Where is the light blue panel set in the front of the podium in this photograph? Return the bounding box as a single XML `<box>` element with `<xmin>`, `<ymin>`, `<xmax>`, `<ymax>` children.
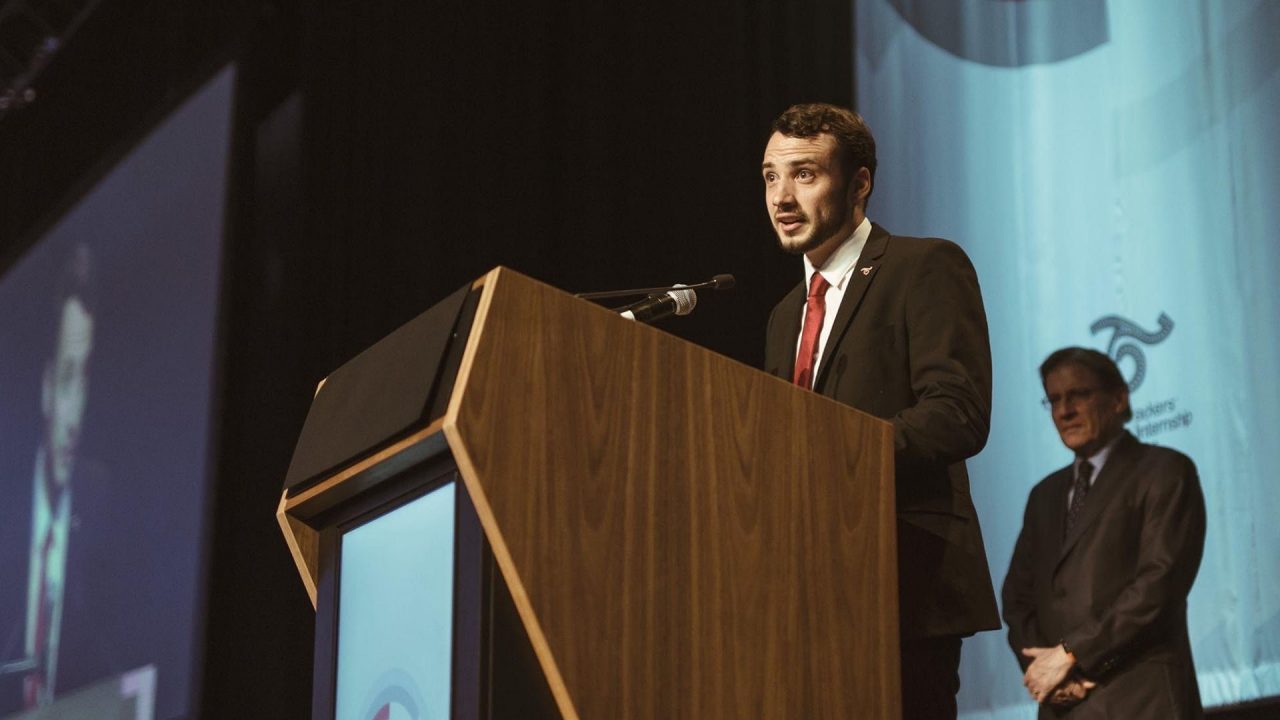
<box><xmin>334</xmin><ymin>482</ymin><xmax>456</xmax><ymax>720</ymax></box>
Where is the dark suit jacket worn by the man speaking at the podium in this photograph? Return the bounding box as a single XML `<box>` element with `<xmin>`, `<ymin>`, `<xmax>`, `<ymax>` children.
<box><xmin>764</xmin><ymin>224</ymin><xmax>1000</xmax><ymax>637</ymax></box>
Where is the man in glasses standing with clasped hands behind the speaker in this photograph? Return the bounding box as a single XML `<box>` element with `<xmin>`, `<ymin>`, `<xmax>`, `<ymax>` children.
<box><xmin>1004</xmin><ymin>347</ymin><xmax>1204</xmax><ymax>720</ymax></box>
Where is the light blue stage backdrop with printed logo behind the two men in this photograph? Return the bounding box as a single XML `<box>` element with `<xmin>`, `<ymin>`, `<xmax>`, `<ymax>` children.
<box><xmin>855</xmin><ymin>0</ymin><xmax>1280</xmax><ymax>719</ymax></box>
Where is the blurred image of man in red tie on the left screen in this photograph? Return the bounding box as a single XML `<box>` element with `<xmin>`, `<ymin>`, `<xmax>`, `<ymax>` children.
<box><xmin>23</xmin><ymin>245</ymin><xmax>93</xmax><ymax>708</ymax></box>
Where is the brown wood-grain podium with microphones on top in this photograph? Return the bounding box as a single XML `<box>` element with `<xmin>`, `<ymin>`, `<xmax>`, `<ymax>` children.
<box><xmin>278</xmin><ymin>268</ymin><xmax>901</xmax><ymax>720</ymax></box>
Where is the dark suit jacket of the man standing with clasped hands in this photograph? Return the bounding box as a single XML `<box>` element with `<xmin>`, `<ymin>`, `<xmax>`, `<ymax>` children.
<box><xmin>1002</xmin><ymin>433</ymin><xmax>1204</xmax><ymax>720</ymax></box>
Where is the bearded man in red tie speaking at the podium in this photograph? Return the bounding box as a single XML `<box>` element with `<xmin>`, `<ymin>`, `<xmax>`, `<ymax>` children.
<box><xmin>762</xmin><ymin>105</ymin><xmax>1000</xmax><ymax>719</ymax></box>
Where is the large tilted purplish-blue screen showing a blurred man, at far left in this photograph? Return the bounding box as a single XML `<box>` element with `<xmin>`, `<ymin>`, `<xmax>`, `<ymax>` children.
<box><xmin>0</xmin><ymin>68</ymin><xmax>234</xmax><ymax>720</ymax></box>
